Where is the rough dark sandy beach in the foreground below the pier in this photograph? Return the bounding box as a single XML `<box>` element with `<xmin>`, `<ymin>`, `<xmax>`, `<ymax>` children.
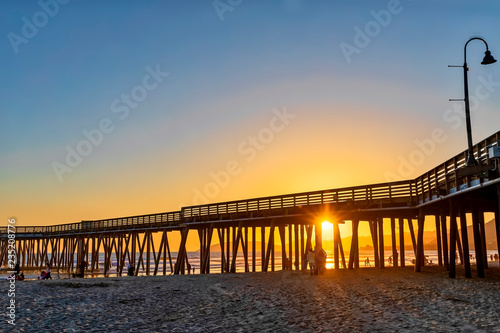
<box><xmin>0</xmin><ymin>267</ymin><xmax>500</xmax><ymax>332</ymax></box>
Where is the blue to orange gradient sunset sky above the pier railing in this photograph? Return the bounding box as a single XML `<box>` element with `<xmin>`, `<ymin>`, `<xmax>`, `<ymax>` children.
<box><xmin>0</xmin><ymin>0</ymin><xmax>500</xmax><ymax>239</ymax></box>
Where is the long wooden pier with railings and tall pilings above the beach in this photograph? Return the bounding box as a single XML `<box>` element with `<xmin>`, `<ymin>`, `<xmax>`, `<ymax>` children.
<box><xmin>0</xmin><ymin>132</ymin><xmax>500</xmax><ymax>277</ymax></box>
